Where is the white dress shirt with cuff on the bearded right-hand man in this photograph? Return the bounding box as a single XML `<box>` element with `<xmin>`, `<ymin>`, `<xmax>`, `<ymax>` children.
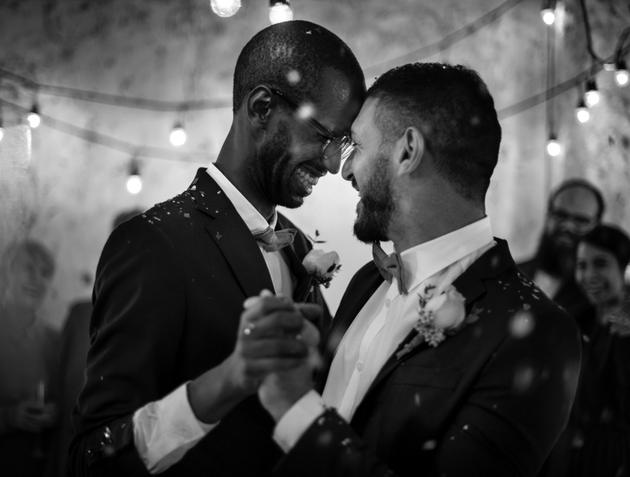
<box><xmin>274</xmin><ymin>217</ymin><xmax>495</xmax><ymax>452</ymax></box>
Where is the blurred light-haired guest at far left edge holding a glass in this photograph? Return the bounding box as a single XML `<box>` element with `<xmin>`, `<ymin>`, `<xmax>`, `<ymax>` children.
<box><xmin>0</xmin><ymin>240</ymin><xmax>57</xmax><ymax>477</ymax></box>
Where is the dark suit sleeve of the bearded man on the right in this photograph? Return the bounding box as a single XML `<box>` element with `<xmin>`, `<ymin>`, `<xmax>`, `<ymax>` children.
<box><xmin>275</xmin><ymin>304</ymin><xmax>580</xmax><ymax>477</ymax></box>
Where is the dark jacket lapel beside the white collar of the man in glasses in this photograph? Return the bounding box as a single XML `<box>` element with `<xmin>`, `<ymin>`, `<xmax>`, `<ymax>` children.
<box><xmin>186</xmin><ymin>169</ymin><xmax>273</xmax><ymax>296</ymax></box>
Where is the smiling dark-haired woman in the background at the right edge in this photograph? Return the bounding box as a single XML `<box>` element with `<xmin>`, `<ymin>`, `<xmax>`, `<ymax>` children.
<box><xmin>545</xmin><ymin>225</ymin><xmax>630</xmax><ymax>477</ymax></box>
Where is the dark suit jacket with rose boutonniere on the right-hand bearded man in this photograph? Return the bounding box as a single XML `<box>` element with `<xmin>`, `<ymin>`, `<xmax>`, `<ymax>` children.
<box><xmin>276</xmin><ymin>240</ymin><xmax>580</xmax><ymax>477</ymax></box>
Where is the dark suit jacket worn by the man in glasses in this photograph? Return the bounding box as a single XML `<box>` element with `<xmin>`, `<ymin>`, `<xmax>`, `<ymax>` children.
<box><xmin>70</xmin><ymin>169</ymin><xmax>327</xmax><ymax>477</ymax></box>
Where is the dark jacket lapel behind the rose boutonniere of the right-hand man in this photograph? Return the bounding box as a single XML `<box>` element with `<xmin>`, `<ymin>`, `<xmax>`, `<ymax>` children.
<box><xmin>352</xmin><ymin>239</ymin><xmax>514</xmax><ymax>422</ymax></box>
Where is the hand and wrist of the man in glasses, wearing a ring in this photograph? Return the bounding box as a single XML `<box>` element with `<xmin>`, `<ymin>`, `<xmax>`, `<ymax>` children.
<box><xmin>187</xmin><ymin>291</ymin><xmax>316</xmax><ymax>423</ymax></box>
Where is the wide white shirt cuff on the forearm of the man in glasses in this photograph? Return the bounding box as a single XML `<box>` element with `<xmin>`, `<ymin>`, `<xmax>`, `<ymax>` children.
<box><xmin>133</xmin><ymin>383</ymin><xmax>218</xmax><ymax>474</ymax></box>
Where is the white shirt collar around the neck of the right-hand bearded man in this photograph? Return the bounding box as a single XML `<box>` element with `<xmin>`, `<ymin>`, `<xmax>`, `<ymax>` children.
<box><xmin>400</xmin><ymin>217</ymin><xmax>494</xmax><ymax>291</ymax></box>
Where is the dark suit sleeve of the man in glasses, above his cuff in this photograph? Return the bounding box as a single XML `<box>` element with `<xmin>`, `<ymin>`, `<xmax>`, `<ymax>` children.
<box><xmin>69</xmin><ymin>217</ymin><xmax>186</xmax><ymax>476</ymax></box>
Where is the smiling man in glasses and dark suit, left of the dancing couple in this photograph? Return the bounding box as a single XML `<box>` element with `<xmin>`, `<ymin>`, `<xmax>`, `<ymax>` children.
<box><xmin>70</xmin><ymin>21</ymin><xmax>365</xmax><ymax>477</ymax></box>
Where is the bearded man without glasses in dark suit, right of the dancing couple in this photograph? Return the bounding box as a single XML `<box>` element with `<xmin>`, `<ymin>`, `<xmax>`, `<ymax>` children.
<box><xmin>248</xmin><ymin>63</ymin><xmax>580</xmax><ymax>477</ymax></box>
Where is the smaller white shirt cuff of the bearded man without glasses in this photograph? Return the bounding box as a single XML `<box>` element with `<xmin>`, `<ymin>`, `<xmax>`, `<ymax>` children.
<box><xmin>273</xmin><ymin>390</ymin><xmax>326</xmax><ymax>452</ymax></box>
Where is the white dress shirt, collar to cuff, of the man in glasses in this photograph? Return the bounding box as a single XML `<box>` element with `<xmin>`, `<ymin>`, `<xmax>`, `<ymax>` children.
<box><xmin>133</xmin><ymin>164</ymin><xmax>293</xmax><ymax>474</ymax></box>
